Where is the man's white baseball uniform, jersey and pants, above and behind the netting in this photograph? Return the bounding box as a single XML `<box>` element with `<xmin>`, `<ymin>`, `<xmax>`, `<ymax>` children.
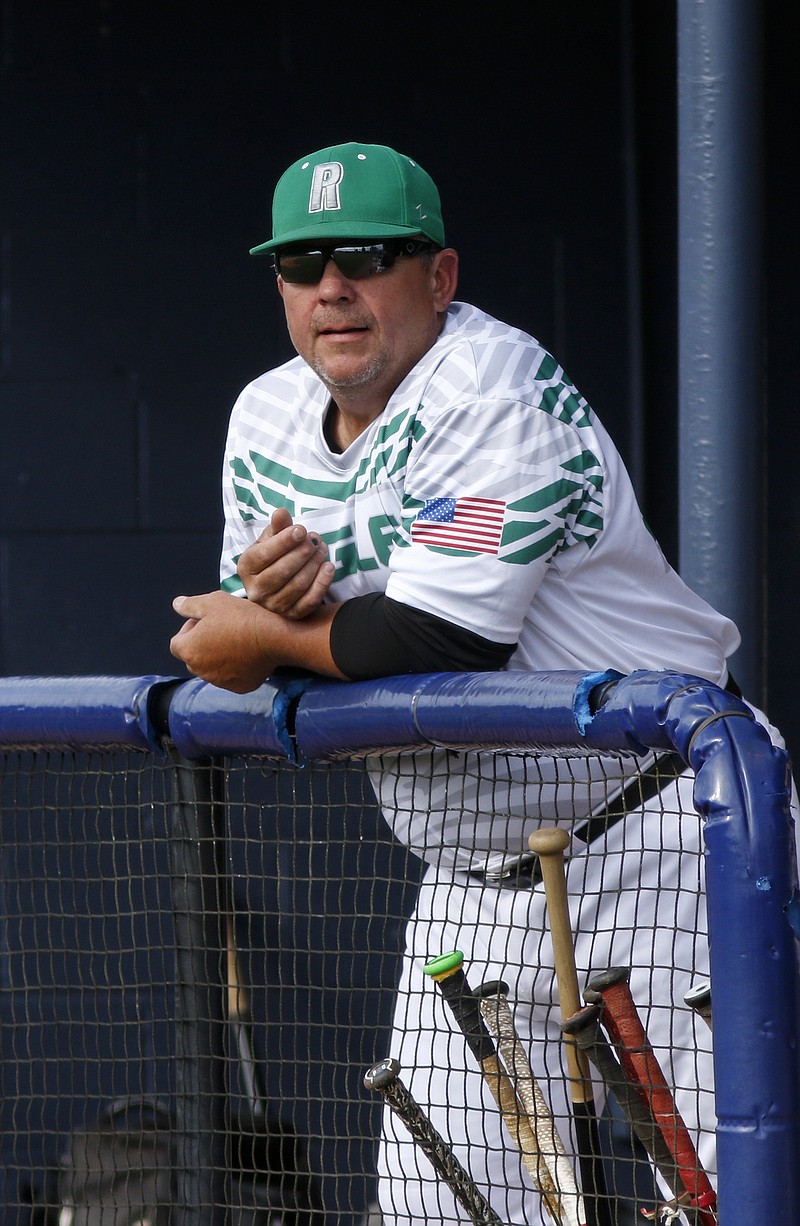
<box><xmin>222</xmin><ymin>303</ymin><xmax>759</xmax><ymax>1226</ymax></box>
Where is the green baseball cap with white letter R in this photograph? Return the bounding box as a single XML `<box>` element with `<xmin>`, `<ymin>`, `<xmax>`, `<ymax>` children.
<box><xmin>250</xmin><ymin>141</ymin><xmax>445</xmax><ymax>255</ymax></box>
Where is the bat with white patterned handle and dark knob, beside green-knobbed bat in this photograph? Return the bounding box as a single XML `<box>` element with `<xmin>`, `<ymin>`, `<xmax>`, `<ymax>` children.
<box><xmin>473</xmin><ymin>980</ymin><xmax>586</xmax><ymax>1226</ymax></box>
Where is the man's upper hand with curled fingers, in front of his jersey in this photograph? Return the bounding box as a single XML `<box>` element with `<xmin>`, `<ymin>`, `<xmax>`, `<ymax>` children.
<box><xmin>238</xmin><ymin>508</ymin><xmax>336</xmax><ymax>620</ymax></box>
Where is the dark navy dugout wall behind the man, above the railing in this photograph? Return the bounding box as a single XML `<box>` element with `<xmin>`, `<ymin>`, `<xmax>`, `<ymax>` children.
<box><xmin>0</xmin><ymin>0</ymin><xmax>800</xmax><ymax>745</ymax></box>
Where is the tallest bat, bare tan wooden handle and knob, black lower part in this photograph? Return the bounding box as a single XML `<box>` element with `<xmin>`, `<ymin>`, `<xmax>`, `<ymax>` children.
<box><xmin>528</xmin><ymin>826</ymin><xmax>614</xmax><ymax>1226</ymax></box>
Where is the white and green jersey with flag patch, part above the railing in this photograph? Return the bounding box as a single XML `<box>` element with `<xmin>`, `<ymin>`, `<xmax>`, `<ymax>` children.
<box><xmin>221</xmin><ymin>296</ymin><xmax>739</xmax><ymax>682</ymax></box>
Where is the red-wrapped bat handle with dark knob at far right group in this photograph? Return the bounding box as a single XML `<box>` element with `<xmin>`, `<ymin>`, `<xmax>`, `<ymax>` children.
<box><xmin>589</xmin><ymin>967</ymin><xmax>718</xmax><ymax>1226</ymax></box>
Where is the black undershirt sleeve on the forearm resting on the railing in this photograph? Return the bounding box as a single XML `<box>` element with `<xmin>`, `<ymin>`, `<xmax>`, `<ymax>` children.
<box><xmin>331</xmin><ymin>592</ymin><xmax>516</xmax><ymax>680</ymax></box>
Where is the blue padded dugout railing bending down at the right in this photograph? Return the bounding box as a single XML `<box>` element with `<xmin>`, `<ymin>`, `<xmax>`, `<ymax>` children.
<box><xmin>0</xmin><ymin>672</ymin><xmax>800</xmax><ymax>1226</ymax></box>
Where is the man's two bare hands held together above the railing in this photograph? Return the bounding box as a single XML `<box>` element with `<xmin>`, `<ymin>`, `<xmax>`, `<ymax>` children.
<box><xmin>169</xmin><ymin>509</ymin><xmax>334</xmax><ymax>694</ymax></box>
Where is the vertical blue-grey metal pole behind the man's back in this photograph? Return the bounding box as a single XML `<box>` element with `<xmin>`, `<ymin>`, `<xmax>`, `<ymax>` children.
<box><xmin>677</xmin><ymin>0</ymin><xmax>764</xmax><ymax>702</ymax></box>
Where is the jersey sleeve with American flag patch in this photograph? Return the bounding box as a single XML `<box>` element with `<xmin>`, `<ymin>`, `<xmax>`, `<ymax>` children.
<box><xmin>386</xmin><ymin>384</ymin><xmax>604</xmax><ymax>642</ymax></box>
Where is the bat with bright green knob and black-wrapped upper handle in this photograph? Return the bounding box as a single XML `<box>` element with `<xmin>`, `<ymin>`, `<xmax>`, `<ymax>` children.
<box><xmin>424</xmin><ymin>950</ymin><xmax>566</xmax><ymax>1226</ymax></box>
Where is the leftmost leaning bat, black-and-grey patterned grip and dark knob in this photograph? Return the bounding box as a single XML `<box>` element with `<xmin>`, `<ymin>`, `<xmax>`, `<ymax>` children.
<box><xmin>364</xmin><ymin>1057</ymin><xmax>502</xmax><ymax>1226</ymax></box>
